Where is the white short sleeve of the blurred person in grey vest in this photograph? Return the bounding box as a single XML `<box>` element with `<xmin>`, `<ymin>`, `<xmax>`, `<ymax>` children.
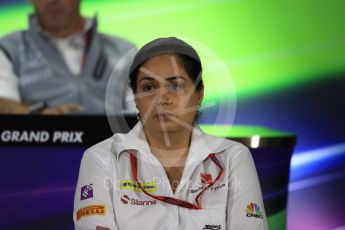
<box><xmin>0</xmin><ymin>49</ymin><xmax>21</xmax><ymax>102</ymax></box>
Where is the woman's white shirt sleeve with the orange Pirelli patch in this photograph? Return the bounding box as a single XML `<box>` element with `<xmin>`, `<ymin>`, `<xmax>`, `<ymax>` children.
<box><xmin>73</xmin><ymin>152</ymin><xmax>118</xmax><ymax>230</ymax></box>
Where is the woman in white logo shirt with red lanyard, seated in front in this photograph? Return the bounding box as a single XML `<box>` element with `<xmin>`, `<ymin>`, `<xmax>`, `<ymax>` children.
<box><xmin>73</xmin><ymin>38</ymin><xmax>267</xmax><ymax>230</ymax></box>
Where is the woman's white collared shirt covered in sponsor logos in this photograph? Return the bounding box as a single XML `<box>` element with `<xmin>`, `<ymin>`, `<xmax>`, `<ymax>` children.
<box><xmin>73</xmin><ymin>122</ymin><xmax>267</xmax><ymax>230</ymax></box>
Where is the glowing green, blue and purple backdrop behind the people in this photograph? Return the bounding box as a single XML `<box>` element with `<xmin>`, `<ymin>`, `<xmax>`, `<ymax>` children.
<box><xmin>0</xmin><ymin>0</ymin><xmax>345</xmax><ymax>229</ymax></box>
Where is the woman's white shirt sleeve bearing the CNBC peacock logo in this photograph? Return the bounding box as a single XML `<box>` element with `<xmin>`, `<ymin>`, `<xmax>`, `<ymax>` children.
<box><xmin>226</xmin><ymin>148</ymin><xmax>268</xmax><ymax>230</ymax></box>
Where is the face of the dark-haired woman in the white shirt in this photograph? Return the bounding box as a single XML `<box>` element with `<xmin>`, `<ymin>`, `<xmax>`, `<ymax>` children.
<box><xmin>135</xmin><ymin>54</ymin><xmax>203</xmax><ymax>132</ymax></box>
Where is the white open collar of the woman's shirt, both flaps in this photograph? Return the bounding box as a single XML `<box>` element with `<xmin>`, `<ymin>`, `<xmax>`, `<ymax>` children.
<box><xmin>112</xmin><ymin>122</ymin><xmax>234</xmax><ymax>165</ymax></box>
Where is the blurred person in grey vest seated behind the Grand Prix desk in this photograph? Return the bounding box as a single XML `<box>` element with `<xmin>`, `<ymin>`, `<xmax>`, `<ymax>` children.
<box><xmin>0</xmin><ymin>0</ymin><xmax>134</xmax><ymax>114</ymax></box>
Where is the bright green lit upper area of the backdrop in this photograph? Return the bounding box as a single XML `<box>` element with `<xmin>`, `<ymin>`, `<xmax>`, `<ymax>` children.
<box><xmin>0</xmin><ymin>0</ymin><xmax>345</xmax><ymax>101</ymax></box>
